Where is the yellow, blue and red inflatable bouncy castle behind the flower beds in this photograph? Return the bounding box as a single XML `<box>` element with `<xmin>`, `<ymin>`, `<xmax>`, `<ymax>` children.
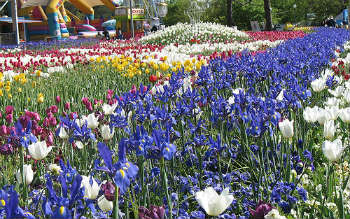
<box><xmin>19</xmin><ymin>0</ymin><xmax>120</xmax><ymax>40</ymax></box>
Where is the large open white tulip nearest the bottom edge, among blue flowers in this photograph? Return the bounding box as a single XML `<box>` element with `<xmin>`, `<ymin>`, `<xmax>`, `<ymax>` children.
<box><xmin>195</xmin><ymin>187</ymin><xmax>233</xmax><ymax>216</ymax></box>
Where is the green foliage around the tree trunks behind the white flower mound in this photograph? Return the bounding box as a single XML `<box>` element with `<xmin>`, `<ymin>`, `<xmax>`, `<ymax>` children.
<box><xmin>164</xmin><ymin>0</ymin><xmax>346</xmax><ymax>30</ymax></box>
